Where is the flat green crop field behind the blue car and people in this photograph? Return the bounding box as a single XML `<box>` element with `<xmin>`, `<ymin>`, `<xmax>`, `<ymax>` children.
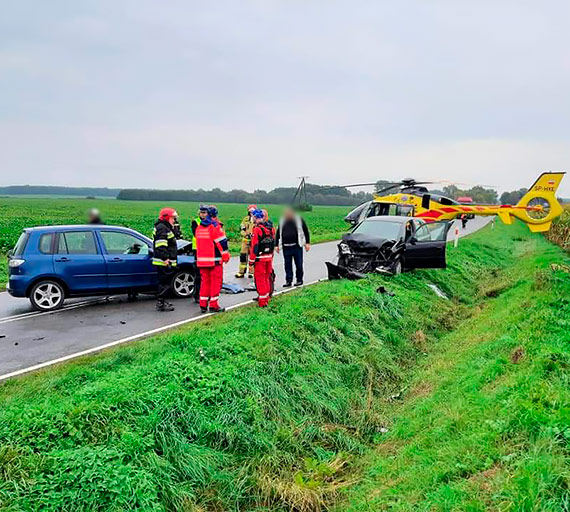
<box><xmin>0</xmin><ymin>197</ymin><xmax>352</xmax><ymax>286</ymax></box>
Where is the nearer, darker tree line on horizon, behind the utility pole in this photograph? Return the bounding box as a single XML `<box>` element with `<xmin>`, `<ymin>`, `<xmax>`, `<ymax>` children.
<box><xmin>117</xmin><ymin>184</ymin><xmax>372</xmax><ymax>206</ymax></box>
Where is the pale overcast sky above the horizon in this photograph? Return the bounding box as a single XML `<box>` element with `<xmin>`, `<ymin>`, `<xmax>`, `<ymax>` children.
<box><xmin>0</xmin><ymin>0</ymin><xmax>570</xmax><ymax>196</ymax></box>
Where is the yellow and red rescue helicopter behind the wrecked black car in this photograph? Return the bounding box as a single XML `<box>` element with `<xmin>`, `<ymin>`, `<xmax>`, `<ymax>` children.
<box><xmin>338</xmin><ymin>172</ymin><xmax>565</xmax><ymax>233</ymax></box>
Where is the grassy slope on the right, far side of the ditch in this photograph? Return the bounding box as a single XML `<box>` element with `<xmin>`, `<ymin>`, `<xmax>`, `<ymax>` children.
<box><xmin>339</xmin><ymin>227</ymin><xmax>570</xmax><ymax>512</ymax></box>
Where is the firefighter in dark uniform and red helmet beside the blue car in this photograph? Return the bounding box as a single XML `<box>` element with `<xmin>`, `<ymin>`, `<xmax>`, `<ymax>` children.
<box><xmin>152</xmin><ymin>208</ymin><xmax>178</xmax><ymax>311</ymax></box>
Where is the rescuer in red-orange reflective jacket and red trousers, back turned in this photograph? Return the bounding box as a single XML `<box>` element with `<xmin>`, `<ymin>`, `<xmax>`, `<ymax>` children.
<box><xmin>196</xmin><ymin>206</ymin><xmax>230</xmax><ymax>313</ymax></box>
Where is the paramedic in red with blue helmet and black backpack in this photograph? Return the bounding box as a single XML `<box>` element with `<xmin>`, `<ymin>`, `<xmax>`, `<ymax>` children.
<box><xmin>249</xmin><ymin>210</ymin><xmax>275</xmax><ymax>308</ymax></box>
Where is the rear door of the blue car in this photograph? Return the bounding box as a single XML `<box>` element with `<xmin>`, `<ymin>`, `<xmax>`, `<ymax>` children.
<box><xmin>53</xmin><ymin>229</ymin><xmax>107</xmax><ymax>293</ymax></box>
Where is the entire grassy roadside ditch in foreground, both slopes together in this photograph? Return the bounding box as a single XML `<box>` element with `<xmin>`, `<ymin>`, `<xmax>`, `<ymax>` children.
<box><xmin>0</xmin><ymin>225</ymin><xmax>570</xmax><ymax>511</ymax></box>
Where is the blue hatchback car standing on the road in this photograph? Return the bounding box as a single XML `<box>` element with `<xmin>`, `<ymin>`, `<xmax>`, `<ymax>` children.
<box><xmin>8</xmin><ymin>225</ymin><xmax>195</xmax><ymax>311</ymax></box>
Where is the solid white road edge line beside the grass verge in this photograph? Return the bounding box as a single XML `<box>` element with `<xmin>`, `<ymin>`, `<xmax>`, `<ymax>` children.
<box><xmin>0</xmin><ymin>279</ymin><xmax>323</xmax><ymax>381</ymax></box>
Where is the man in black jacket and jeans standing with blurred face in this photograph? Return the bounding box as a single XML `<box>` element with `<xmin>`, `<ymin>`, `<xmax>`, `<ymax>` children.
<box><xmin>275</xmin><ymin>208</ymin><xmax>311</xmax><ymax>288</ymax></box>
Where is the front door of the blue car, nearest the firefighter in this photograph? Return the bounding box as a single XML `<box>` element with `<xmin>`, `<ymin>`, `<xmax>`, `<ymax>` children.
<box><xmin>99</xmin><ymin>228</ymin><xmax>157</xmax><ymax>291</ymax></box>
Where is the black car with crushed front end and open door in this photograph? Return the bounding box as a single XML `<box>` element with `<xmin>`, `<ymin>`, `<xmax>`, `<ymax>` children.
<box><xmin>326</xmin><ymin>215</ymin><xmax>452</xmax><ymax>279</ymax></box>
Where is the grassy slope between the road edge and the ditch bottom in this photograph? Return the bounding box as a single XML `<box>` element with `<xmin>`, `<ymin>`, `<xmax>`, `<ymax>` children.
<box><xmin>0</xmin><ymin>225</ymin><xmax>566</xmax><ymax>511</ymax></box>
